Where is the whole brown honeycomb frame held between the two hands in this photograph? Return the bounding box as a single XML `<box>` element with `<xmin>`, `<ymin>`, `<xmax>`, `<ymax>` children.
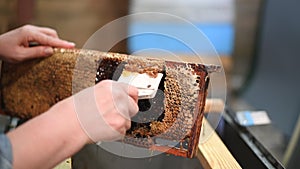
<box><xmin>1</xmin><ymin>49</ymin><xmax>214</xmax><ymax>158</ymax></box>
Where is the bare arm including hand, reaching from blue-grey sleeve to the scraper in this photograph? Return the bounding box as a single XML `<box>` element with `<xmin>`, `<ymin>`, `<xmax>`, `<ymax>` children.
<box><xmin>8</xmin><ymin>80</ymin><xmax>138</xmax><ymax>169</ymax></box>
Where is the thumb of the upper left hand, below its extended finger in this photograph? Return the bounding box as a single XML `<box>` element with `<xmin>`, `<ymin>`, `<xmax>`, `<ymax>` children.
<box><xmin>22</xmin><ymin>46</ymin><xmax>54</xmax><ymax>59</ymax></box>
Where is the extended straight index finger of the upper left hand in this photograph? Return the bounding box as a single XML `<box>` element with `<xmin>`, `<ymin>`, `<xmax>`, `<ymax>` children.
<box><xmin>30</xmin><ymin>32</ymin><xmax>75</xmax><ymax>48</ymax></box>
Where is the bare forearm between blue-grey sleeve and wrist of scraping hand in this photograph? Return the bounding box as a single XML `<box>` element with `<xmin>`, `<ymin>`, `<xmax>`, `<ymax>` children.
<box><xmin>8</xmin><ymin>98</ymin><xmax>88</xmax><ymax>169</ymax></box>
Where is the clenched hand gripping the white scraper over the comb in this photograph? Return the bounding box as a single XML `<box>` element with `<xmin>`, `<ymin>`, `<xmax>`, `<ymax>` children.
<box><xmin>74</xmin><ymin>80</ymin><xmax>138</xmax><ymax>142</ymax></box>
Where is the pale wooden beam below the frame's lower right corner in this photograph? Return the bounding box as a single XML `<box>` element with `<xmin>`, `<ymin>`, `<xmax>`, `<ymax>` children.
<box><xmin>197</xmin><ymin>118</ymin><xmax>241</xmax><ymax>169</ymax></box>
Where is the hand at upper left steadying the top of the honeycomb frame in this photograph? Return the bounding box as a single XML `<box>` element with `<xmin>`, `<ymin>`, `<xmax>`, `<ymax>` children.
<box><xmin>0</xmin><ymin>25</ymin><xmax>75</xmax><ymax>63</ymax></box>
